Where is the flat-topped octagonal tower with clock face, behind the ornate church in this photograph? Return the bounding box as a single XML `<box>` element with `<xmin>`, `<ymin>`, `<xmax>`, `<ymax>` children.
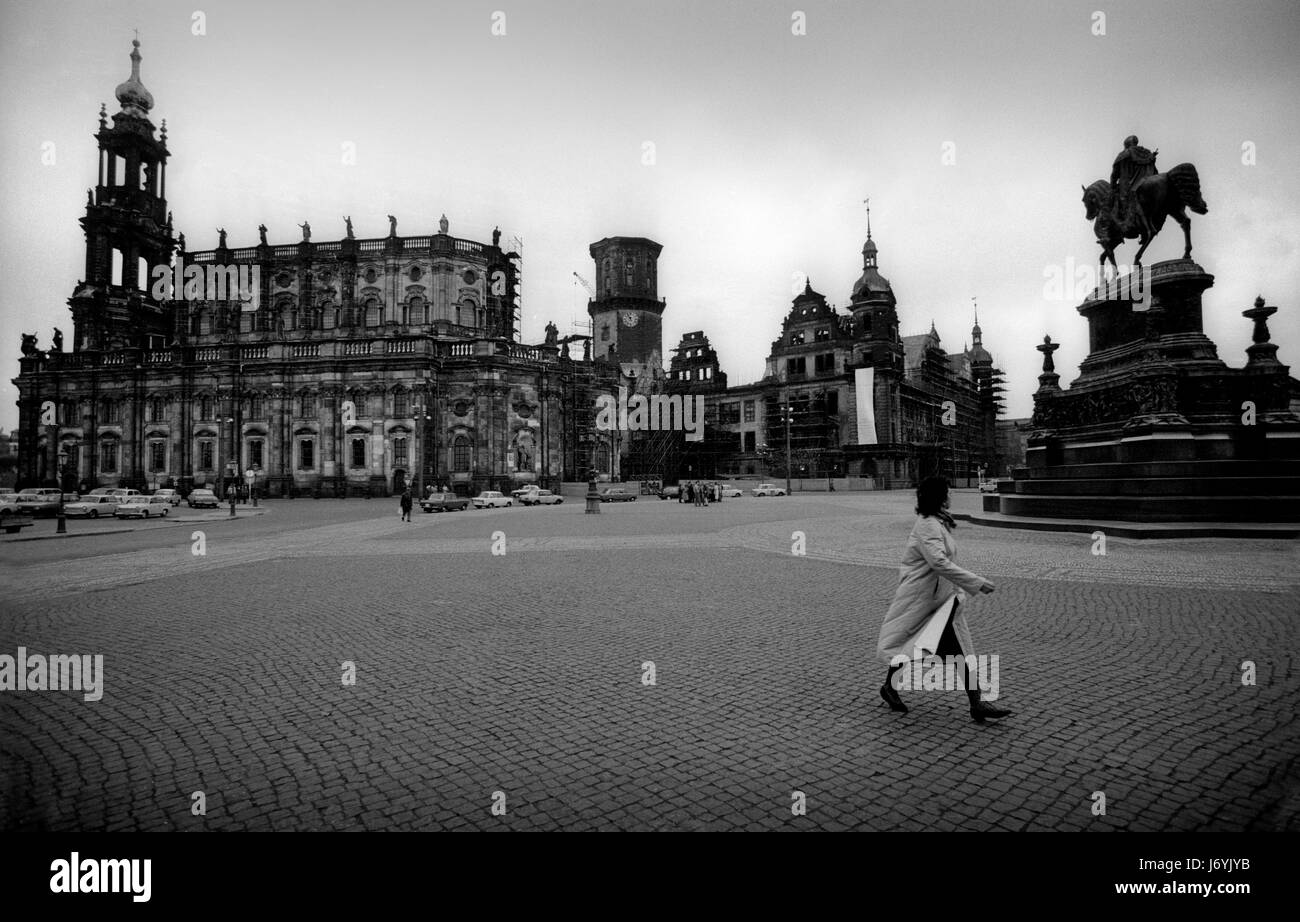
<box><xmin>586</xmin><ymin>237</ymin><xmax>667</xmax><ymax>376</ymax></box>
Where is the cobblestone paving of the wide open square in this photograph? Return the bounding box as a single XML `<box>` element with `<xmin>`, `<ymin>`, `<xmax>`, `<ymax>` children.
<box><xmin>0</xmin><ymin>494</ymin><xmax>1300</xmax><ymax>830</ymax></box>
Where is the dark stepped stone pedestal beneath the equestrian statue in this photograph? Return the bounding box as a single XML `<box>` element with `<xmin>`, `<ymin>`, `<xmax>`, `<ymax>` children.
<box><xmin>984</xmin><ymin>259</ymin><xmax>1300</xmax><ymax>521</ymax></box>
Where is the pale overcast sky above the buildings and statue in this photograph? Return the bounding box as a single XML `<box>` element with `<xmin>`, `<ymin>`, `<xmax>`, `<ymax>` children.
<box><xmin>0</xmin><ymin>0</ymin><xmax>1300</xmax><ymax>429</ymax></box>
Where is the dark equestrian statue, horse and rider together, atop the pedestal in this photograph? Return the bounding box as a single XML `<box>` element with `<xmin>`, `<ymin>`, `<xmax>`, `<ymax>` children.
<box><xmin>1083</xmin><ymin>135</ymin><xmax>1208</xmax><ymax>273</ymax></box>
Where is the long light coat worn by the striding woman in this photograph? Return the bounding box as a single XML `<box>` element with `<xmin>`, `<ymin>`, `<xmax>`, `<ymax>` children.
<box><xmin>876</xmin><ymin>515</ymin><xmax>984</xmax><ymax>663</ymax></box>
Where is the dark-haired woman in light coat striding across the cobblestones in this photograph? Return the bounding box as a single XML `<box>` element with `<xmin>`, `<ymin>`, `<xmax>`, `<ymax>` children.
<box><xmin>876</xmin><ymin>477</ymin><xmax>1011</xmax><ymax>723</ymax></box>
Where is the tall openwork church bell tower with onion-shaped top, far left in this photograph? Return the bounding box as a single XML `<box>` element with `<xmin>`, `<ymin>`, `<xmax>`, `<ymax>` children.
<box><xmin>68</xmin><ymin>40</ymin><xmax>176</xmax><ymax>351</ymax></box>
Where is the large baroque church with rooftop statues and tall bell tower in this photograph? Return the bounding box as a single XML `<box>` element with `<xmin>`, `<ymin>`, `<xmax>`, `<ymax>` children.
<box><xmin>14</xmin><ymin>42</ymin><xmax>626</xmax><ymax>495</ymax></box>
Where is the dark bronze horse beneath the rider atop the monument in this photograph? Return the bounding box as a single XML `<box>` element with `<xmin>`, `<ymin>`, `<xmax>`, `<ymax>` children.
<box><xmin>1083</xmin><ymin>164</ymin><xmax>1209</xmax><ymax>274</ymax></box>
